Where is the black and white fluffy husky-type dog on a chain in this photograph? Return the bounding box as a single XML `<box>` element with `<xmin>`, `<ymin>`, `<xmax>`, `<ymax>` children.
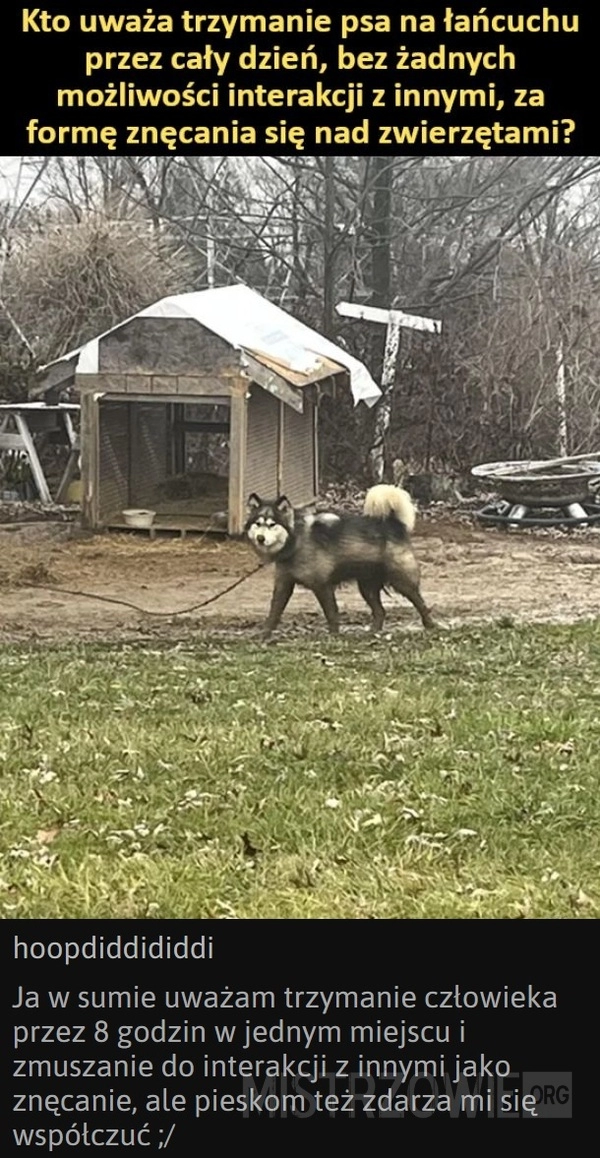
<box><xmin>244</xmin><ymin>485</ymin><xmax>434</xmax><ymax>639</ymax></box>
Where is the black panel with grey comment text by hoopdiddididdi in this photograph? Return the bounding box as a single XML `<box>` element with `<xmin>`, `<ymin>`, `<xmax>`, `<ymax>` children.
<box><xmin>2</xmin><ymin>921</ymin><xmax>597</xmax><ymax>1155</ymax></box>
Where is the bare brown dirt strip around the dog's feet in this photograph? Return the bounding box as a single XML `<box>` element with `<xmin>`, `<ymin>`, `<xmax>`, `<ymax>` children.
<box><xmin>0</xmin><ymin>515</ymin><xmax>600</xmax><ymax>642</ymax></box>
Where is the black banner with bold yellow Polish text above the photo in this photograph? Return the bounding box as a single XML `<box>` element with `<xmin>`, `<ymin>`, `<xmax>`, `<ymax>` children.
<box><xmin>1</xmin><ymin>2</ymin><xmax>599</xmax><ymax>155</ymax></box>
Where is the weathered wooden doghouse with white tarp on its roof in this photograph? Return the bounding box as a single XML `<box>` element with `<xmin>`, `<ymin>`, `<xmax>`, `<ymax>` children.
<box><xmin>35</xmin><ymin>285</ymin><xmax>380</xmax><ymax>535</ymax></box>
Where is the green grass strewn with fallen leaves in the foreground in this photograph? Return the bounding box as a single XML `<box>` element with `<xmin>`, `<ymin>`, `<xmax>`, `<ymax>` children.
<box><xmin>0</xmin><ymin>622</ymin><xmax>600</xmax><ymax>918</ymax></box>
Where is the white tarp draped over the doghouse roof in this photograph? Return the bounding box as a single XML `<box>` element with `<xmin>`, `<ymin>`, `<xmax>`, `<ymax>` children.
<box><xmin>51</xmin><ymin>285</ymin><xmax>381</xmax><ymax>406</ymax></box>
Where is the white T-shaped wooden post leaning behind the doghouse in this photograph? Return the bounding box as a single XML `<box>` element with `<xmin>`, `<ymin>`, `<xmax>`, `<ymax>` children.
<box><xmin>336</xmin><ymin>301</ymin><xmax>441</xmax><ymax>483</ymax></box>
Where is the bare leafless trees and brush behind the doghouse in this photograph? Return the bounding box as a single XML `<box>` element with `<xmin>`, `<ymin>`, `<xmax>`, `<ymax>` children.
<box><xmin>2</xmin><ymin>155</ymin><xmax>600</xmax><ymax>477</ymax></box>
